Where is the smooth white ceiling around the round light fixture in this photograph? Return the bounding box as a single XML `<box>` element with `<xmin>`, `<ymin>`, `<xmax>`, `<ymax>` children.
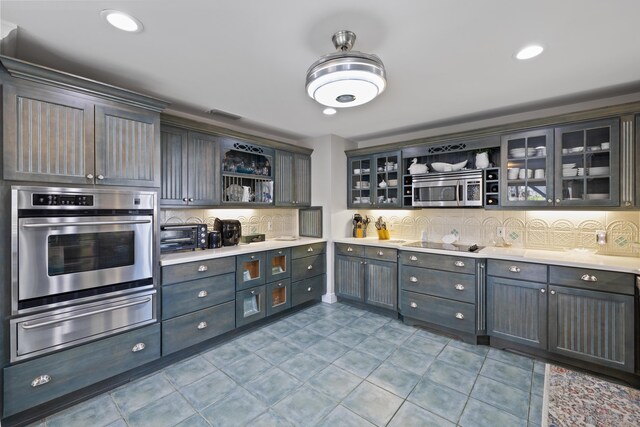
<box><xmin>0</xmin><ymin>0</ymin><xmax>640</xmax><ymax>141</ymax></box>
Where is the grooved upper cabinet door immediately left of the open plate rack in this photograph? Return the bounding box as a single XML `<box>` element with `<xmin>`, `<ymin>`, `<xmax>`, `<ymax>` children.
<box><xmin>187</xmin><ymin>132</ymin><xmax>221</xmax><ymax>206</ymax></box>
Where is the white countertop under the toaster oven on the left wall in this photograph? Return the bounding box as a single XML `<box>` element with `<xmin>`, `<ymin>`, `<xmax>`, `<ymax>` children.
<box><xmin>160</xmin><ymin>237</ymin><xmax>326</xmax><ymax>266</ymax></box>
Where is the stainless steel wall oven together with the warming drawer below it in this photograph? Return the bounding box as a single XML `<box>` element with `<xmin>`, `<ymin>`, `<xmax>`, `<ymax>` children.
<box><xmin>10</xmin><ymin>186</ymin><xmax>156</xmax><ymax>361</ymax></box>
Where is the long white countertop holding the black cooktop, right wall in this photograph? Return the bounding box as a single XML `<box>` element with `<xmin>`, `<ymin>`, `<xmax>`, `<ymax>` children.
<box><xmin>334</xmin><ymin>237</ymin><xmax>640</xmax><ymax>274</ymax></box>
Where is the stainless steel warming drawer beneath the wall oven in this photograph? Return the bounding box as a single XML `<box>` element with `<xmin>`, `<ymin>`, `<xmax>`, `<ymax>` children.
<box><xmin>11</xmin><ymin>290</ymin><xmax>156</xmax><ymax>362</ymax></box>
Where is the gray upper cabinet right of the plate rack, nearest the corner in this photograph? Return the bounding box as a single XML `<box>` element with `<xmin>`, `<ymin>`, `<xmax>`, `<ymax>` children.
<box><xmin>275</xmin><ymin>150</ymin><xmax>311</xmax><ymax>207</ymax></box>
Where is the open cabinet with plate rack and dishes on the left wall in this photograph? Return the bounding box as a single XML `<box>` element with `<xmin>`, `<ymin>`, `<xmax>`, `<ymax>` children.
<box><xmin>221</xmin><ymin>138</ymin><xmax>275</xmax><ymax>205</ymax></box>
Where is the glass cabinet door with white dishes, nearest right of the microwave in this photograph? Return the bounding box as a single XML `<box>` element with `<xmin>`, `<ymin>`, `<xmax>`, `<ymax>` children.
<box><xmin>500</xmin><ymin>129</ymin><xmax>554</xmax><ymax>206</ymax></box>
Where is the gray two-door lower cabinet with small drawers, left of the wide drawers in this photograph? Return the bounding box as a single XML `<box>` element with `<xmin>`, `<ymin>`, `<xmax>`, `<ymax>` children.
<box><xmin>334</xmin><ymin>243</ymin><xmax>398</xmax><ymax>310</ymax></box>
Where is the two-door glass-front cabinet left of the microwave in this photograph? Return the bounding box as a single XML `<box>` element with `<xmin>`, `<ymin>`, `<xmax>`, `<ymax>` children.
<box><xmin>347</xmin><ymin>151</ymin><xmax>402</xmax><ymax>208</ymax></box>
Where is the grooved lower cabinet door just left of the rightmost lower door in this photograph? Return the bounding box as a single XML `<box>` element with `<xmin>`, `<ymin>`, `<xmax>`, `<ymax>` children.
<box><xmin>487</xmin><ymin>277</ymin><xmax>547</xmax><ymax>349</ymax></box>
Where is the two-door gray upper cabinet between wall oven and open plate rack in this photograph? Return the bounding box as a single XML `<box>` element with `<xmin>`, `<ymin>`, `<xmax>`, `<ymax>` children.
<box><xmin>160</xmin><ymin>126</ymin><xmax>220</xmax><ymax>206</ymax></box>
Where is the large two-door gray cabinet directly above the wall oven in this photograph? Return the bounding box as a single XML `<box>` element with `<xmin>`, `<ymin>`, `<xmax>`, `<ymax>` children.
<box><xmin>3</xmin><ymin>83</ymin><xmax>160</xmax><ymax>187</ymax></box>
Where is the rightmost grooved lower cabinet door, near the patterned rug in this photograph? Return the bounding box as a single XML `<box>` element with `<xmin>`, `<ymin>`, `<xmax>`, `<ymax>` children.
<box><xmin>549</xmin><ymin>286</ymin><xmax>634</xmax><ymax>372</ymax></box>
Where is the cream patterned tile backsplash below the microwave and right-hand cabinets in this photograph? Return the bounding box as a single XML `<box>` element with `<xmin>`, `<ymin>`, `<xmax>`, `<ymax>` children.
<box><xmin>354</xmin><ymin>209</ymin><xmax>640</xmax><ymax>256</ymax></box>
